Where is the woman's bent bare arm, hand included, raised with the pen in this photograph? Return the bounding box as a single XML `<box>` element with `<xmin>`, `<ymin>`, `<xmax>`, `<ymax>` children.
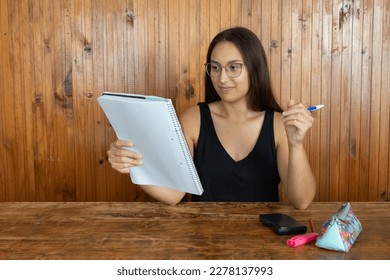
<box><xmin>274</xmin><ymin>101</ymin><xmax>316</xmax><ymax>209</ymax></box>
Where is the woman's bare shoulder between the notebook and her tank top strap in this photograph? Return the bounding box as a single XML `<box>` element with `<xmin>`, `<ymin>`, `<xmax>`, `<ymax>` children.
<box><xmin>179</xmin><ymin>105</ymin><xmax>200</xmax><ymax>145</ymax></box>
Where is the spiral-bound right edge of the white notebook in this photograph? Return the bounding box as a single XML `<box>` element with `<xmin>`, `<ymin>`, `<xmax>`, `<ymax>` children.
<box><xmin>167</xmin><ymin>99</ymin><xmax>203</xmax><ymax>194</ymax></box>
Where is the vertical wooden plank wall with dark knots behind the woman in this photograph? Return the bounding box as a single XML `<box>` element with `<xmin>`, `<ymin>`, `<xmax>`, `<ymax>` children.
<box><xmin>0</xmin><ymin>0</ymin><xmax>390</xmax><ymax>201</ymax></box>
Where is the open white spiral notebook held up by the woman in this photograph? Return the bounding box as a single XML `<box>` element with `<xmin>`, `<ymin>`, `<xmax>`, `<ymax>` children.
<box><xmin>98</xmin><ymin>92</ymin><xmax>203</xmax><ymax>195</ymax></box>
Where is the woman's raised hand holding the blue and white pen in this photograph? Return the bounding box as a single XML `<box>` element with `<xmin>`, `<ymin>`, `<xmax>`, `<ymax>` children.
<box><xmin>283</xmin><ymin>100</ymin><xmax>314</xmax><ymax>145</ymax></box>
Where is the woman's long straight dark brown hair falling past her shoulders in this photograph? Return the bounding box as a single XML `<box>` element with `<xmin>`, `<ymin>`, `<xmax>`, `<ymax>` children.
<box><xmin>205</xmin><ymin>27</ymin><xmax>283</xmax><ymax>112</ymax></box>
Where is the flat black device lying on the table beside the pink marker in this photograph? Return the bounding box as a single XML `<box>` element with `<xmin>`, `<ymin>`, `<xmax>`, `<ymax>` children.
<box><xmin>259</xmin><ymin>213</ymin><xmax>307</xmax><ymax>235</ymax></box>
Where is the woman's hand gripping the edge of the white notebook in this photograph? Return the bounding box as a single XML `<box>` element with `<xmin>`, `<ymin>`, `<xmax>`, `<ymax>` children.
<box><xmin>107</xmin><ymin>140</ymin><xmax>142</xmax><ymax>173</ymax></box>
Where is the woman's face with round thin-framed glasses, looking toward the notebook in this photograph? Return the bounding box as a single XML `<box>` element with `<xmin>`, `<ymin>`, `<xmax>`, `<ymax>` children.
<box><xmin>210</xmin><ymin>41</ymin><xmax>249</xmax><ymax>105</ymax></box>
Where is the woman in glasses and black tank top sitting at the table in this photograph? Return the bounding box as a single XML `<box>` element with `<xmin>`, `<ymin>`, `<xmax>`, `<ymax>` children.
<box><xmin>108</xmin><ymin>27</ymin><xmax>316</xmax><ymax>209</ymax></box>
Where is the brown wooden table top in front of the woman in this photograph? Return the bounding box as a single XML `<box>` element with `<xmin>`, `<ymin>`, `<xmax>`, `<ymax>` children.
<box><xmin>0</xmin><ymin>202</ymin><xmax>390</xmax><ymax>260</ymax></box>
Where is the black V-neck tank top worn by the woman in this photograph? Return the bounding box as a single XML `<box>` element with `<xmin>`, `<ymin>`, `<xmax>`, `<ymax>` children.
<box><xmin>192</xmin><ymin>103</ymin><xmax>280</xmax><ymax>202</ymax></box>
